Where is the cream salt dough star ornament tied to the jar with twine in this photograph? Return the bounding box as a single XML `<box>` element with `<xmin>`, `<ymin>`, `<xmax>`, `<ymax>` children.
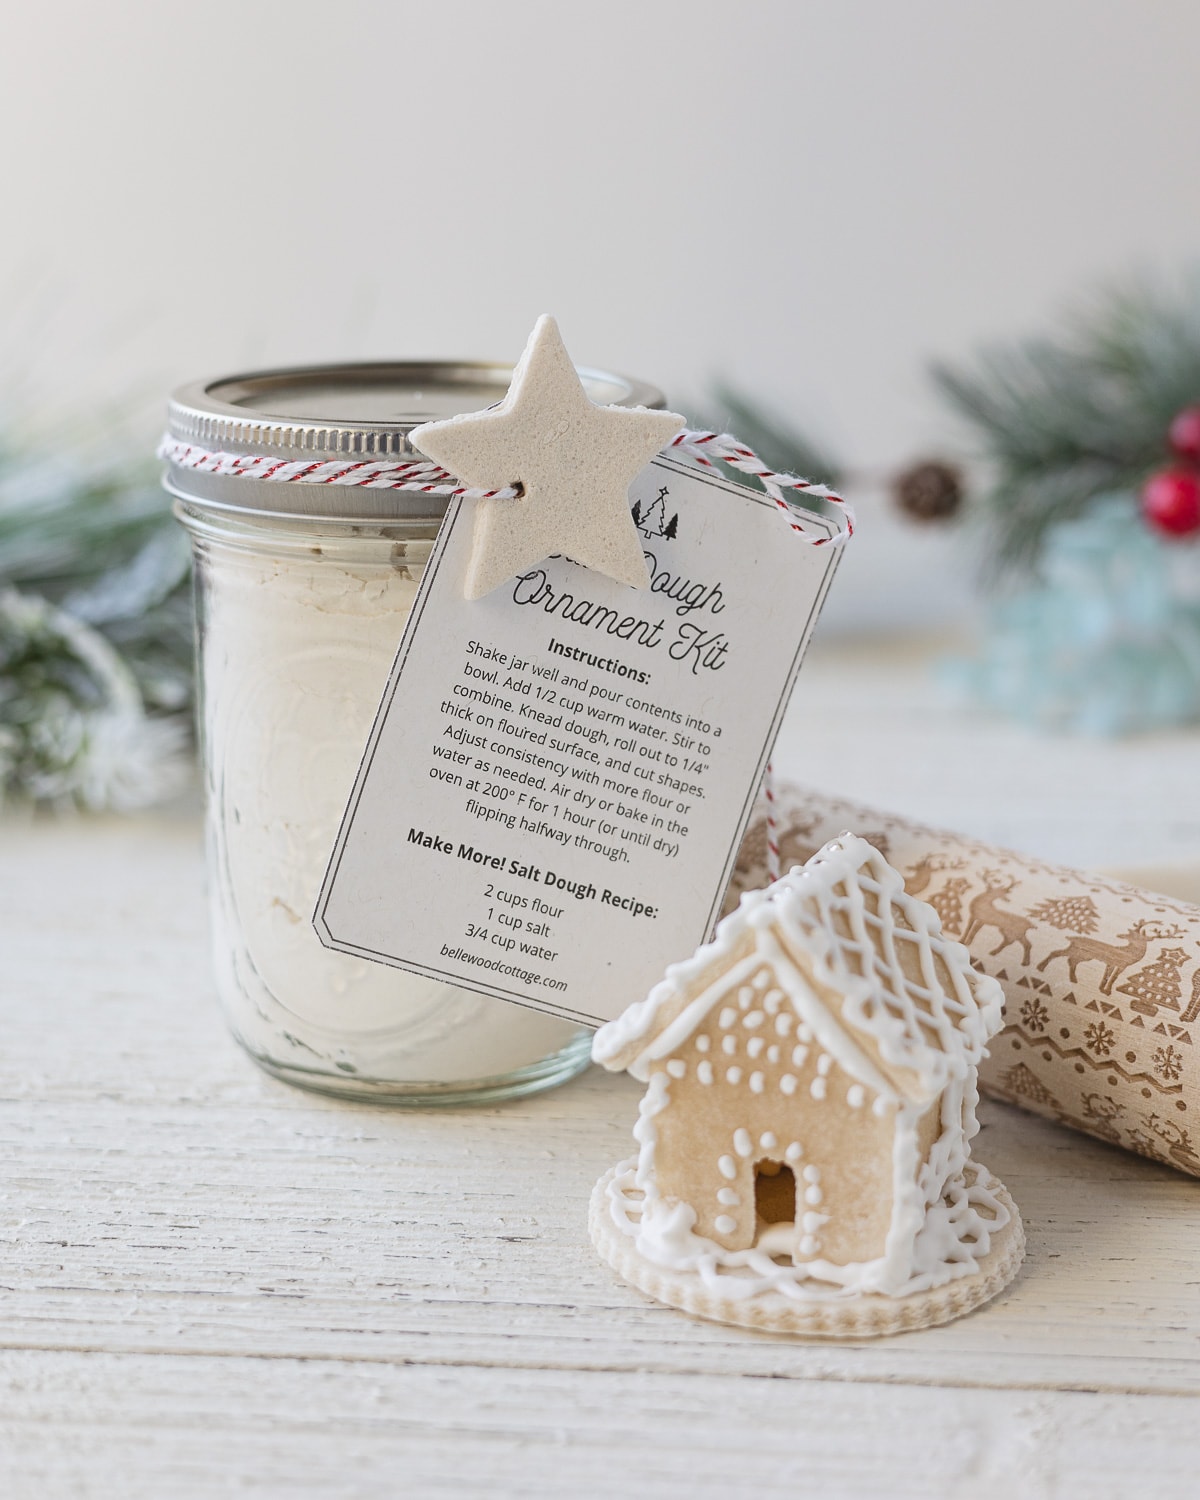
<box><xmin>411</xmin><ymin>317</ymin><xmax>684</xmax><ymax>599</ymax></box>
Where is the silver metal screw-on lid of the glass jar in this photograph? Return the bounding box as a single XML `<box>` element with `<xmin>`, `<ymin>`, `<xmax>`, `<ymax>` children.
<box><xmin>164</xmin><ymin>360</ymin><xmax>666</xmax><ymax>521</ymax></box>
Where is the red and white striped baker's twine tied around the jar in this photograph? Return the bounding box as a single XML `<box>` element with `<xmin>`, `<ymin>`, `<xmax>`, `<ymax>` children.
<box><xmin>158</xmin><ymin>428</ymin><xmax>855</xmax><ymax>881</ymax></box>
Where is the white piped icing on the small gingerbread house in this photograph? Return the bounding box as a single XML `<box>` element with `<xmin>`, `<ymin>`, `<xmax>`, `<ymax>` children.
<box><xmin>594</xmin><ymin>836</ymin><xmax>1008</xmax><ymax>1298</ymax></box>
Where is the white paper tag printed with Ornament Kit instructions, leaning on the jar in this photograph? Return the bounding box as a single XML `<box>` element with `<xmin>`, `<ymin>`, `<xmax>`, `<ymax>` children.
<box><xmin>315</xmin><ymin>456</ymin><xmax>840</xmax><ymax>1023</ymax></box>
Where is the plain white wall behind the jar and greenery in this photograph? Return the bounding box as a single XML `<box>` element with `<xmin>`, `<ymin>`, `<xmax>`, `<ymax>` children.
<box><xmin>0</xmin><ymin>0</ymin><xmax>1200</xmax><ymax>623</ymax></box>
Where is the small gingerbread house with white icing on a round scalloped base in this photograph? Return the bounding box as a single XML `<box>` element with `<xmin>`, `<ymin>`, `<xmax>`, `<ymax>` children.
<box><xmin>591</xmin><ymin>834</ymin><xmax>1025</xmax><ymax>1337</ymax></box>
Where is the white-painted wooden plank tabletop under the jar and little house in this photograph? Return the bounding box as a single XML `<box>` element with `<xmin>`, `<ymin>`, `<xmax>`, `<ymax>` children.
<box><xmin>0</xmin><ymin>647</ymin><xmax>1200</xmax><ymax>1500</ymax></box>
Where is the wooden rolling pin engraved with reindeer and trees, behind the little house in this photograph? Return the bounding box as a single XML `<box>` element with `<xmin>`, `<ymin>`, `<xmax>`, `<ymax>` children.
<box><xmin>726</xmin><ymin>785</ymin><xmax>1200</xmax><ymax>1176</ymax></box>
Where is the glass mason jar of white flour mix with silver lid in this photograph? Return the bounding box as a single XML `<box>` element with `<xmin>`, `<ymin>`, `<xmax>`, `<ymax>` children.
<box><xmin>164</xmin><ymin>363</ymin><xmax>663</xmax><ymax>1104</ymax></box>
